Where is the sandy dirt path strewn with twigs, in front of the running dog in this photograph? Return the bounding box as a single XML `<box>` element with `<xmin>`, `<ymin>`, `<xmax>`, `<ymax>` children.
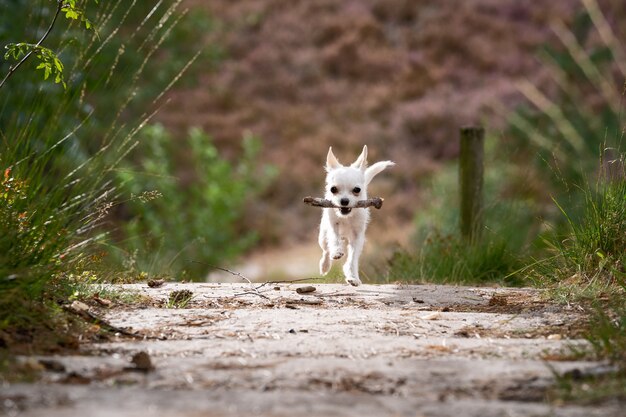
<box><xmin>0</xmin><ymin>284</ymin><xmax>623</xmax><ymax>417</ymax></box>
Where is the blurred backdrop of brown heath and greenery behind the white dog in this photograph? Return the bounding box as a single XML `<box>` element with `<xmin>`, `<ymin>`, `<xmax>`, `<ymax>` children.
<box><xmin>0</xmin><ymin>0</ymin><xmax>626</xmax><ymax>285</ymax></box>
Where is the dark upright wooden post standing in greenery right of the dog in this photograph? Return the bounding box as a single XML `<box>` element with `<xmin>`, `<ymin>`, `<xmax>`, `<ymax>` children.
<box><xmin>459</xmin><ymin>126</ymin><xmax>485</xmax><ymax>242</ymax></box>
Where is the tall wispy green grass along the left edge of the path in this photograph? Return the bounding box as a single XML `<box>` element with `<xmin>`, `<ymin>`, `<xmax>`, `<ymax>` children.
<box><xmin>0</xmin><ymin>1</ymin><xmax>205</xmax><ymax>329</ymax></box>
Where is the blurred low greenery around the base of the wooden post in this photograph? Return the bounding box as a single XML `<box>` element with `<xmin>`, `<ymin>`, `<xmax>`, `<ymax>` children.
<box><xmin>388</xmin><ymin>137</ymin><xmax>538</xmax><ymax>285</ymax></box>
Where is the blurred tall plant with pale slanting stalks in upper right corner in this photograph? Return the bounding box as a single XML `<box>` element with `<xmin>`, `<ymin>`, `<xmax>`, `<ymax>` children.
<box><xmin>507</xmin><ymin>0</ymin><xmax>626</xmax><ymax>197</ymax></box>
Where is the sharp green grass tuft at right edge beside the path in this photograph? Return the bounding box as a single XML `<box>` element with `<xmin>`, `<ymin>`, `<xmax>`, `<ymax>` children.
<box><xmin>532</xmin><ymin>149</ymin><xmax>626</xmax><ymax>405</ymax></box>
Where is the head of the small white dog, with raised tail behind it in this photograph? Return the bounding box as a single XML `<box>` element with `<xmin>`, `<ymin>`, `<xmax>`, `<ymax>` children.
<box><xmin>324</xmin><ymin>145</ymin><xmax>395</xmax><ymax>216</ymax></box>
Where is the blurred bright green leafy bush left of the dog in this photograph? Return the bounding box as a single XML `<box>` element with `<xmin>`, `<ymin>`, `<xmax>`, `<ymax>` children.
<box><xmin>118</xmin><ymin>125</ymin><xmax>273</xmax><ymax>280</ymax></box>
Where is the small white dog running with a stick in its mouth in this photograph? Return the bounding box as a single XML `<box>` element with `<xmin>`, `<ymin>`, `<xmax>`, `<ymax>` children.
<box><xmin>319</xmin><ymin>146</ymin><xmax>395</xmax><ymax>286</ymax></box>
